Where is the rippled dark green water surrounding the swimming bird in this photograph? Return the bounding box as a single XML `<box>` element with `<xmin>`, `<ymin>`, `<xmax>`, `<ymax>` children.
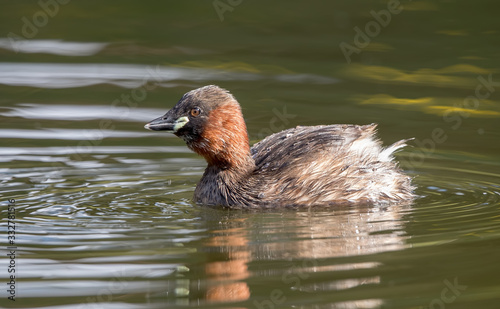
<box><xmin>0</xmin><ymin>0</ymin><xmax>500</xmax><ymax>309</ymax></box>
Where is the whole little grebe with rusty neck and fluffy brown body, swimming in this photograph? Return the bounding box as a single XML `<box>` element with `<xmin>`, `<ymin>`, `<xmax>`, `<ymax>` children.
<box><xmin>144</xmin><ymin>85</ymin><xmax>414</xmax><ymax>208</ymax></box>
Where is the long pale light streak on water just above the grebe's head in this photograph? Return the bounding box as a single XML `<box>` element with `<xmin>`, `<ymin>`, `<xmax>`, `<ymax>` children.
<box><xmin>0</xmin><ymin>62</ymin><xmax>338</xmax><ymax>89</ymax></box>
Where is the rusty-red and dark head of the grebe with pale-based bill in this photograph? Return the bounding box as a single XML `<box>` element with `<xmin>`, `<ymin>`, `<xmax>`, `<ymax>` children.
<box><xmin>144</xmin><ymin>85</ymin><xmax>250</xmax><ymax>168</ymax></box>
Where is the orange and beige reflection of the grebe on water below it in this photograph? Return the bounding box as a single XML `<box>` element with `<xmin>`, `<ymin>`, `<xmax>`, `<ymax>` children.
<box><xmin>190</xmin><ymin>204</ymin><xmax>411</xmax><ymax>308</ymax></box>
